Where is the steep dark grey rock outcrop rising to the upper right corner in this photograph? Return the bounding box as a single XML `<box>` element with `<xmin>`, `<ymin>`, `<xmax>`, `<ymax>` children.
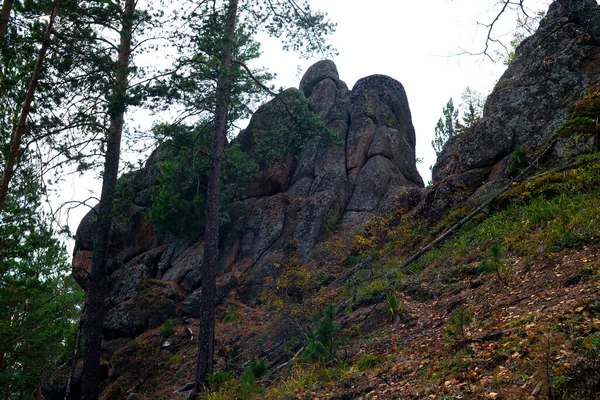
<box><xmin>420</xmin><ymin>0</ymin><xmax>600</xmax><ymax>219</ymax></box>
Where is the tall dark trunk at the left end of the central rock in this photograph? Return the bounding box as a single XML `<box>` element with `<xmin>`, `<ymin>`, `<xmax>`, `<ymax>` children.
<box><xmin>81</xmin><ymin>0</ymin><xmax>136</xmax><ymax>400</ymax></box>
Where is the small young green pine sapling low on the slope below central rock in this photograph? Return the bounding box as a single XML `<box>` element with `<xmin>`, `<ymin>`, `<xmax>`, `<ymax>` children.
<box><xmin>304</xmin><ymin>304</ymin><xmax>341</xmax><ymax>364</ymax></box>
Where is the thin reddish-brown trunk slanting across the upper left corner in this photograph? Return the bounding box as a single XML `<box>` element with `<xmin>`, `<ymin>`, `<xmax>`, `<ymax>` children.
<box><xmin>0</xmin><ymin>0</ymin><xmax>60</xmax><ymax>213</ymax></box>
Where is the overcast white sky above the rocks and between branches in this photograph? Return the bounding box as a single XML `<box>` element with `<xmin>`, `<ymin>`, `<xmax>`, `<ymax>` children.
<box><xmin>56</xmin><ymin>0</ymin><xmax>551</xmax><ymax>242</ymax></box>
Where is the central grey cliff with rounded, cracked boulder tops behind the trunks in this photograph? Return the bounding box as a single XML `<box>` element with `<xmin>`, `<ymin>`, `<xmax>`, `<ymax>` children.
<box><xmin>73</xmin><ymin>61</ymin><xmax>423</xmax><ymax>341</ymax></box>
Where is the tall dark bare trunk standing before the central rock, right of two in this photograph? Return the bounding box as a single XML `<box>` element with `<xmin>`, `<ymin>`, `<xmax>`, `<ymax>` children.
<box><xmin>194</xmin><ymin>0</ymin><xmax>238</xmax><ymax>392</ymax></box>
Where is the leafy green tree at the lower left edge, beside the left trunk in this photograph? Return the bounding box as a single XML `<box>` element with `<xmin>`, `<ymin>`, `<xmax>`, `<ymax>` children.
<box><xmin>0</xmin><ymin>164</ymin><xmax>83</xmax><ymax>398</ymax></box>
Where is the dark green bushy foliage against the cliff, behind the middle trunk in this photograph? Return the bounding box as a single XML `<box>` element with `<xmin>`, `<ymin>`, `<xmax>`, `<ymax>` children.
<box><xmin>149</xmin><ymin>124</ymin><xmax>258</xmax><ymax>234</ymax></box>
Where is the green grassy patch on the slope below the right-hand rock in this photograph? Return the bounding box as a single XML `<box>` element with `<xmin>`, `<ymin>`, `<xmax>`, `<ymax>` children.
<box><xmin>404</xmin><ymin>156</ymin><xmax>600</xmax><ymax>273</ymax></box>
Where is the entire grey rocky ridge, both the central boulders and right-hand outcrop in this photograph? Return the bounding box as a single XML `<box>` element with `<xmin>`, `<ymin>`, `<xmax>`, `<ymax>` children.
<box><xmin>50</xmin><ymin>0</ymin><xmax>600</xmax><ymax>396</ymax></box>
